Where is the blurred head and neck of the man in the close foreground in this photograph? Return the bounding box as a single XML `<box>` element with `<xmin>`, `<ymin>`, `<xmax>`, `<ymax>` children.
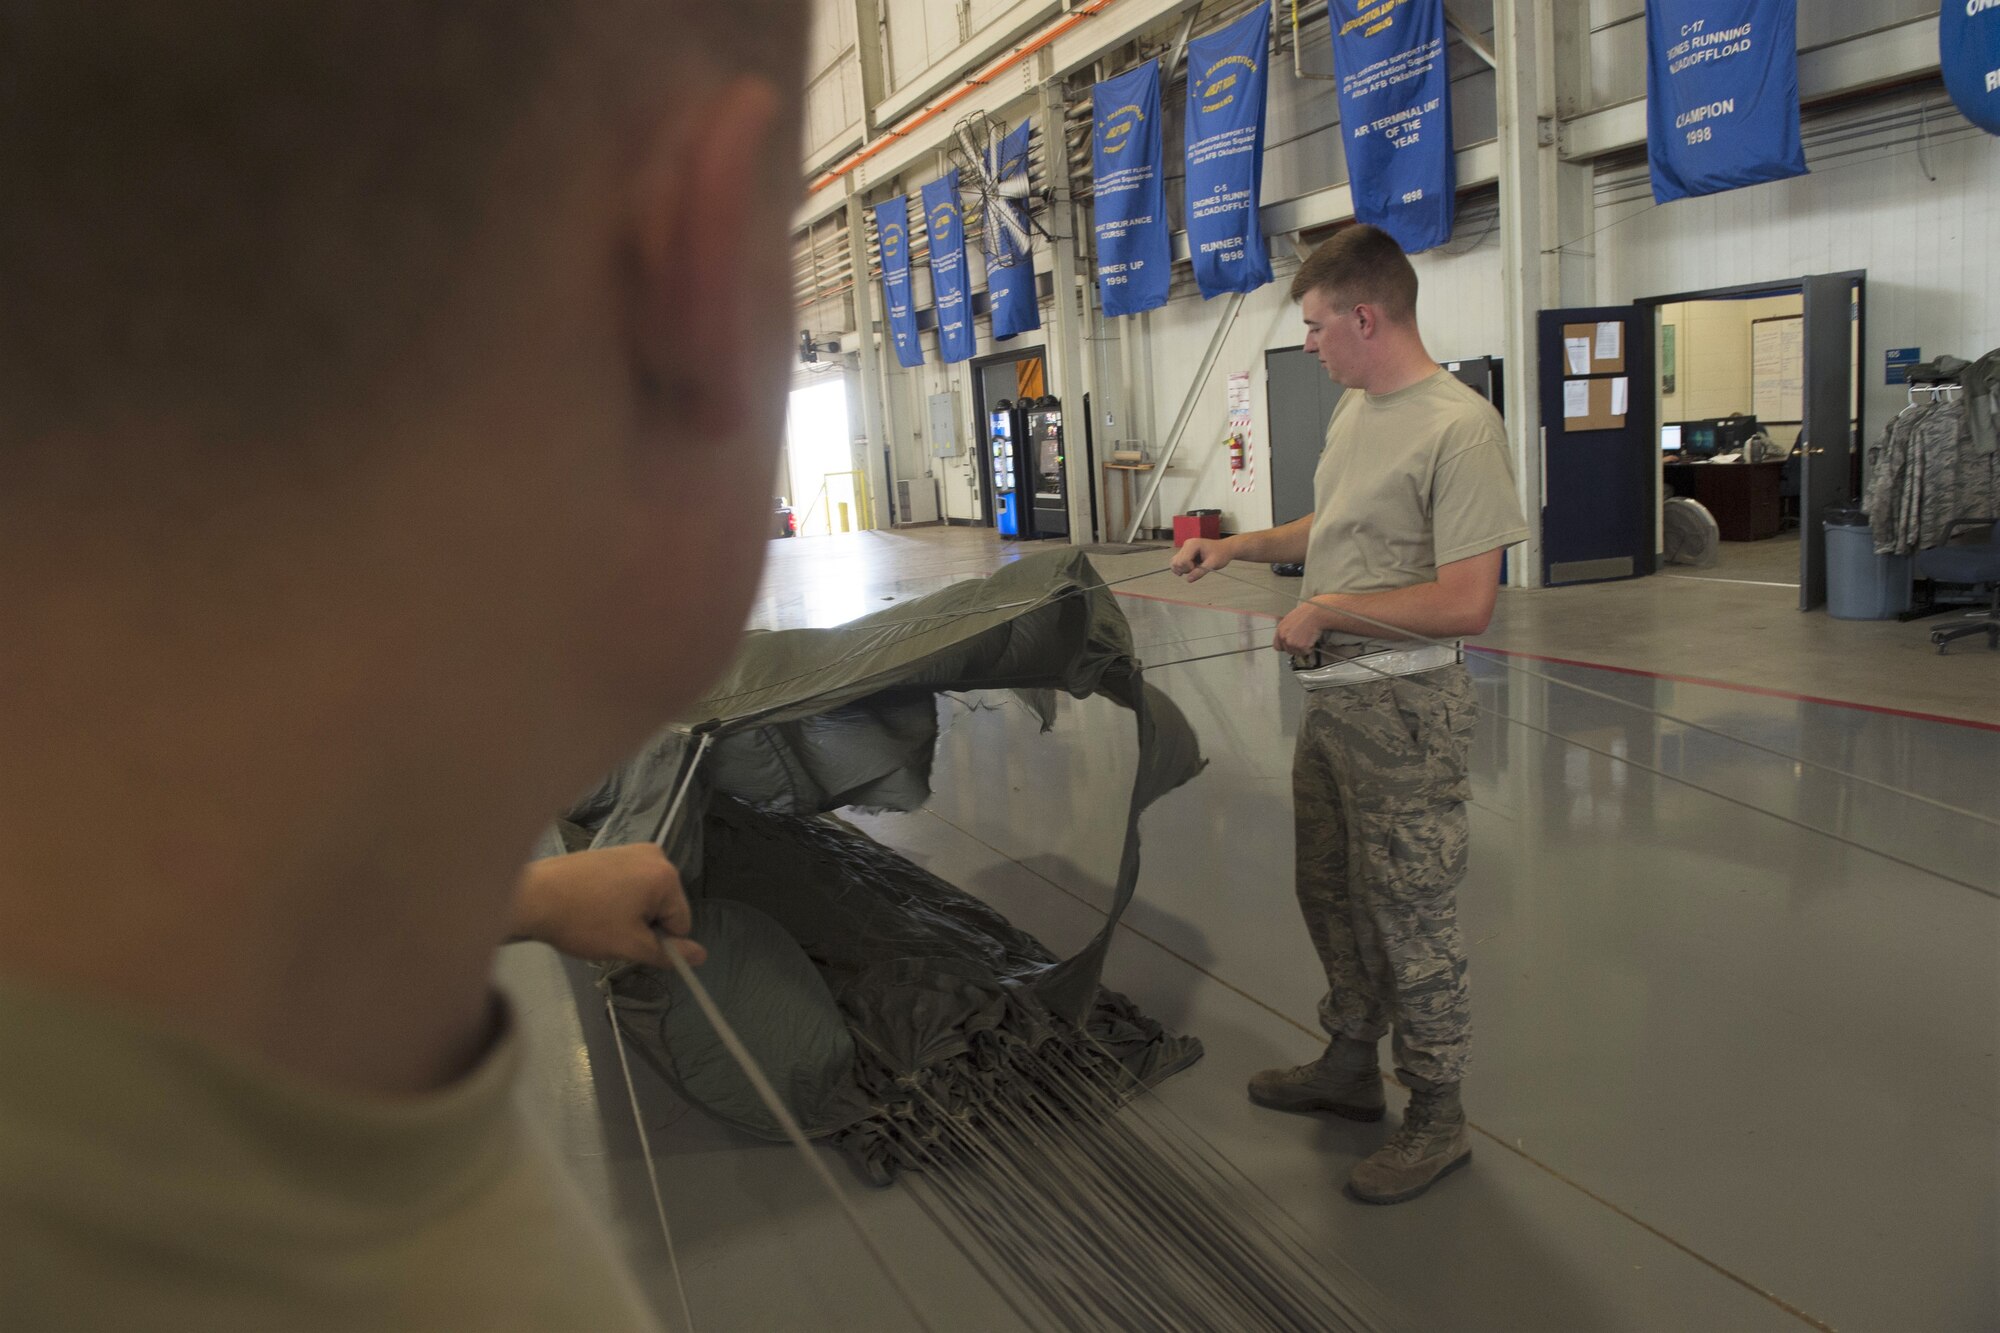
<box><xmin>0</xmin><ymin>0</ymin><xmax>806</xmax><ymax>1089</ymax></box>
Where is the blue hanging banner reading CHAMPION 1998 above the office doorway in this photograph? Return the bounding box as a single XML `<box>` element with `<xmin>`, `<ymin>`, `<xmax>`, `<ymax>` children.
<box><xmin>1646</xmin><ymin>0</ymin><xmax>1816</xmax><ymax>204</ymax></box>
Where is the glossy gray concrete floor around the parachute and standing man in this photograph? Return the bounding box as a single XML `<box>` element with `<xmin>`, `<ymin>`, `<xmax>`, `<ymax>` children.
<box><xmin>504</xmin><ymin>530</ymin><xmax>2000</xmax><ymax>1331</ymax></box>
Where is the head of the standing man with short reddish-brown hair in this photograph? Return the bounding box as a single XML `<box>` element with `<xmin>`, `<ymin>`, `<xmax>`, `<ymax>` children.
<box><xmin>1292</xmin><ymin>224</ymin><xmax>1422</xmax><ymax>388</ymax></box>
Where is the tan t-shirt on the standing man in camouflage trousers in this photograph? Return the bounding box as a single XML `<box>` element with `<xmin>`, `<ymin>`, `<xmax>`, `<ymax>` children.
<box><xmin>1304</xmin><ymin>370</ymin><xmax>1528</xmax><ymax>642</ymax></box>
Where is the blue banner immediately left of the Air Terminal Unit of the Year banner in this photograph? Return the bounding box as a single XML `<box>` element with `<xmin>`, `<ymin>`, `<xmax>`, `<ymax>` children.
<box><xmin>1188</xmin><ymin>6</ymin><xmax>1270</xmax><ymax>298</ymax></box>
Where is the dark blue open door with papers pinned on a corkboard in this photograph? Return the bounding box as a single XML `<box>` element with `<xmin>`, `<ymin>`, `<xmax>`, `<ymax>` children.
<box><xmin>1536</xmin><ymin>306</ymin><xmax>1660</xmax><ymax>586</ymax></box>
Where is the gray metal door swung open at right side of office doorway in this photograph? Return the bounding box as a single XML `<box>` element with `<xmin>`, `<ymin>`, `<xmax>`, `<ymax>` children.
<box><xmin>1798</xmin><ymin>272</ymin><xmax>1862</xmax><ymax>610</ymax></box>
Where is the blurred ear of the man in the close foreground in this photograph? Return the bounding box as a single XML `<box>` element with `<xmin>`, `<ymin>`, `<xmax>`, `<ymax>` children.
<box><xmin>628</xmin><ymin>78</ymin><xmax>796</xmax><ymax>436</ymax></box>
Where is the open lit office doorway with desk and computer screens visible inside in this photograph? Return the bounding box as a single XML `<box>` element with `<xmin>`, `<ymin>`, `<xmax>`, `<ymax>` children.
<box><xmin>1644</xmin><ymin>272</ymin><xmax>1864</xmax><ymax>610</ymax></box>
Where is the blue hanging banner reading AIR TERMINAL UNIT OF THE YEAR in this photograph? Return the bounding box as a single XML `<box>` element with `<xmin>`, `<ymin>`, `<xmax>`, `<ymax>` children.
<box><xmin>1326</xmin><ymin>0</ymin><xmax>1458</xmax><ymax>254</ymax></box>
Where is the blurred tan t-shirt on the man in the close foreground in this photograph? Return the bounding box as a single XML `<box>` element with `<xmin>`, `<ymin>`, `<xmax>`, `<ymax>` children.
<box><xmin>0</xmin><ymin>983</ymin><xmax>656</xmax><ymax>1333</ymax></box>
